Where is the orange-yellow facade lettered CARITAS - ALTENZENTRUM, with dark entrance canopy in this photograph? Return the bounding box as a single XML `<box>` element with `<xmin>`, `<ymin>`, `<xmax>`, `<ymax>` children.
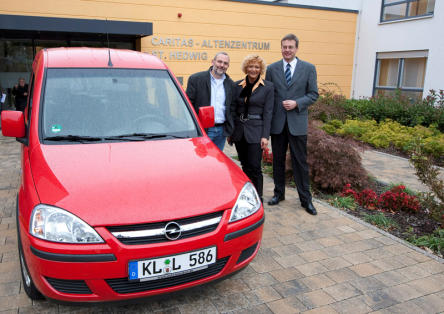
<box><xmin>0</xmin><ymin>0</ymin><xmax>358</xmax><ymax>109</ymax></box>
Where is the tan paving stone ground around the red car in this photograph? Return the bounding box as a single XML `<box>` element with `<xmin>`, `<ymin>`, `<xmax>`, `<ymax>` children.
<box><xmin>0</xmin><ymin>135</ymin><xmax>444</xmax><ymax>314</ymax></box>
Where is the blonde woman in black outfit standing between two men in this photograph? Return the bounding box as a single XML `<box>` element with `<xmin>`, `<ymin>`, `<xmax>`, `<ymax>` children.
<box><xmin>230</xmin><ymin>55</ymin><xmax>274</xmax><ymax>200</ymax></box>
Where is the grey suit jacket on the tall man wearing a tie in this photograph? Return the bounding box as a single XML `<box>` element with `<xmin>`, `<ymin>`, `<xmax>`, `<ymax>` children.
<box><xmin>265</xmin><ymin>59</ymin><xmax>319</xmax><ymax>136</ymax></box>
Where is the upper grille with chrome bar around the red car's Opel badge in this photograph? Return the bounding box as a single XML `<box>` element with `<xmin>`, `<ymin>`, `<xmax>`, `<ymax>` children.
<box><xmin>107</xmin><ymin>211</ymin><xmax>223</xmax><ymax>245</ymax></box>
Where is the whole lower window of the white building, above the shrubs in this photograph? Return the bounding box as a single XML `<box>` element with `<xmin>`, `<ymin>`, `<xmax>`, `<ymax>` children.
<box><xmin>373</xmin><ymin>50</ymin><xmax>428</xmax><ymax>99</ymax></box>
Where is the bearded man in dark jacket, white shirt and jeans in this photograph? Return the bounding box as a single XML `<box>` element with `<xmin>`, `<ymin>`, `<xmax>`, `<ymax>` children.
<box><xmin>186</xmin><ymin>52</ymin><xmax>234</xmax><ymax>150</ymax></box>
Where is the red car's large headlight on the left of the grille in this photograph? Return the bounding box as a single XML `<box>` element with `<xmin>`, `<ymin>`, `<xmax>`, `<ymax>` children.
<box><xmin>30</xmin><ymin>205</ymin><xmax>104</xmax><ymax>243</ymax></box>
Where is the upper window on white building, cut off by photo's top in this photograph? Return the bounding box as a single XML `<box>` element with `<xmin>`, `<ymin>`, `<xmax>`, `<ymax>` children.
<box><xmin>381</xmin><ymin>0</ymin><xmax>435</xmax><ymax>22</ymax></box>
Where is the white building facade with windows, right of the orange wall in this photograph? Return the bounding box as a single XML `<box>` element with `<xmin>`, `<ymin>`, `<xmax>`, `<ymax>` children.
<box><xmin>351</xmin><ymin>0</ymin><xmax>444</xmax><ymax>99</ymax></box>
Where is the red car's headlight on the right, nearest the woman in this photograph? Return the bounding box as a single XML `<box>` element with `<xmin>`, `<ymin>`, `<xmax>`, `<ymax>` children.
<box><xmin>230</xmin><ymin>182</ymin><xmax>261</xmax><ymax>222</ymax></box>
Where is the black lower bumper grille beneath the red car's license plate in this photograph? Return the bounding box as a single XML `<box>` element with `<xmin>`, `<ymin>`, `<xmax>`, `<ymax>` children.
<box><xmin>105</xmin><ymin>256</ymin><xmax>229</xmax><ymax>294</ymax></box>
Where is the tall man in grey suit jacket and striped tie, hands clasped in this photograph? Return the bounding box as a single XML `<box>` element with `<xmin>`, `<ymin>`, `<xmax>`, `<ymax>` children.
<box><xmin>265</xmin><ymin>34</ymin><xmax>319</xmax><ymax>215</ymax></box>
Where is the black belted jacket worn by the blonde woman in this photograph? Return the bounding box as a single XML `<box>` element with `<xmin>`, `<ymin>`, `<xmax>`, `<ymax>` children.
<box><xmin>231</xmin><ymin>79</ymin><xmax>274</xmax><ymax>144</ymax></box>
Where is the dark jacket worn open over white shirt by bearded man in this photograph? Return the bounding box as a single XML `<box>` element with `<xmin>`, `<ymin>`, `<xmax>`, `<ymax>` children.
<box><xmin>186</xmin><ymin>67</ymin><xmax>234</xmax><ymax>136</ymax></box>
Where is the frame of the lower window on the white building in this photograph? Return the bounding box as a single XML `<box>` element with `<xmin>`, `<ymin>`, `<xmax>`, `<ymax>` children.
<box><xmin>372</xmin><ymin>51</ymin><xmax>428</xmax><ymax>98</ymax></box>
